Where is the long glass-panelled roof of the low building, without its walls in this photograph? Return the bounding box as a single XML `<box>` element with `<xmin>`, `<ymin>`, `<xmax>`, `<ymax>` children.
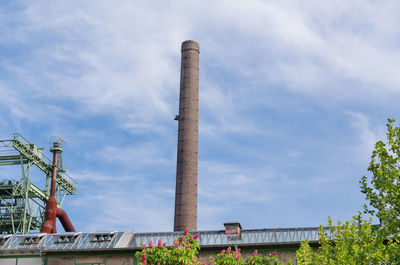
<box><xmin>0</xmin><ymin>227</ymin><xmax>319</xmax><ymax>255</ymax></box>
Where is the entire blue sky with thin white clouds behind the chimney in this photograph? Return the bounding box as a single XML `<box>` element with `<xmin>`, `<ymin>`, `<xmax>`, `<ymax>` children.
<box><xmin>0</xmin><ymin>0</ymin><xmax>400</xmax><ymax>231</ymax></box>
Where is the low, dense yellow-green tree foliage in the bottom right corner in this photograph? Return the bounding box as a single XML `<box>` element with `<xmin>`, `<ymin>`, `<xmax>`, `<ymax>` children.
<box><xmin>297</xmin><ymin>215</ymin><xmax>400</xmax><ymax>265</ymax></box>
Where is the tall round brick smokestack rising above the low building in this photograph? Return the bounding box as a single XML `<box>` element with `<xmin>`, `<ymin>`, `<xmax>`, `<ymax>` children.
<box><xmin>174</xmin><ymin>40</ymin><xmax>200</xmax><ymax>231</ymax></box>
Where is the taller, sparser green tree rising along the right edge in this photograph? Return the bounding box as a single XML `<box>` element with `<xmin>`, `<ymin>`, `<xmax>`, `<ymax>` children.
<box><xmin>360</xmin><ymin>119</ymin><xmax>400</xmax><ymax>235</ymax></box>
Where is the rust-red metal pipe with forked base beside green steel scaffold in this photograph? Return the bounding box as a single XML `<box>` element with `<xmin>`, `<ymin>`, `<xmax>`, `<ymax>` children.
<box><xmin>41</xmin><ymin>142</ymin><xmax>75</xmax><ymax>234</ymax></box>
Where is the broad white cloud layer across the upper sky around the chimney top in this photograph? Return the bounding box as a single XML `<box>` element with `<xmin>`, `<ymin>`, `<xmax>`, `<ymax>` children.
<box><xmin>1</xmin><ymin>1</ymin><xmax>400</xmax><ymax>133</ymax></box>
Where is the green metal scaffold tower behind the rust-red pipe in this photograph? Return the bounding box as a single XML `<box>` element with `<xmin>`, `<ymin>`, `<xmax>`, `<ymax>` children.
<box><xmin>0</xmin><ymin>134</ymin><xmax>77</xmax><ymax>234</ymax></box>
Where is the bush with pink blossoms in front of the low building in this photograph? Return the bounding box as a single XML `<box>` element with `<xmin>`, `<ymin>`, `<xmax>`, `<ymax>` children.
<box><xmin>135</xmin><ymin>230</ymin><xmax>288</xmax><ymax>265</ymax></box>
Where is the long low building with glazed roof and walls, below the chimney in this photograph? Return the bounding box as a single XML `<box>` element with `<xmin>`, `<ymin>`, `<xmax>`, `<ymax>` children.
<box><xmin>0</xmin><ymin>223</ymin><xmax>319</xmax><ymax>265</ymax></box>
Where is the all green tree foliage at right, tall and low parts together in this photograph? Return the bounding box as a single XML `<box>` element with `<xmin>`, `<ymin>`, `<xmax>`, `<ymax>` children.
<box><xmin>297</xmin><ymin>119</ymin><xmax>400</xmax><ymax>265</ymax></box>
